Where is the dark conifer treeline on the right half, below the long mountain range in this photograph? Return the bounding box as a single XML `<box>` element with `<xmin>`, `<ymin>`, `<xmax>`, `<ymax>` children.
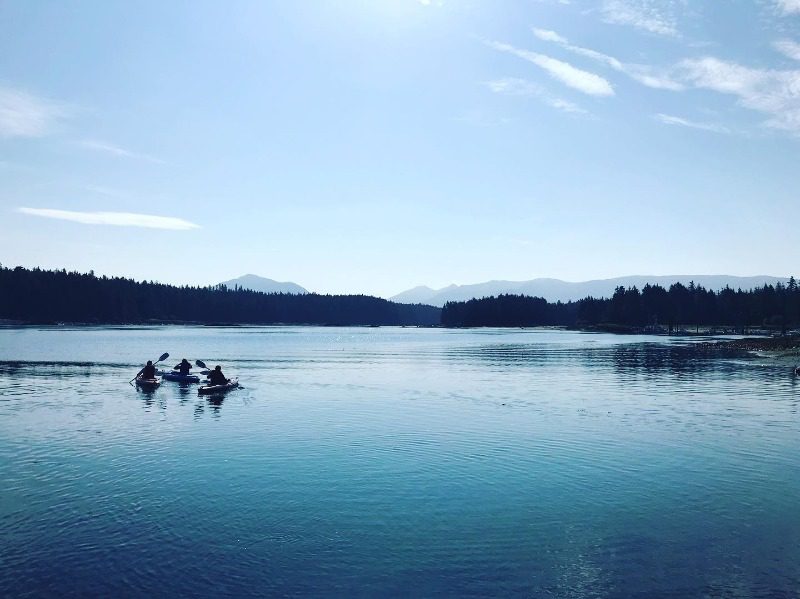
<box><xmin>442</xmin><ymin>277</ymin><xmax>800</xmax><ymax>332</ymax></box>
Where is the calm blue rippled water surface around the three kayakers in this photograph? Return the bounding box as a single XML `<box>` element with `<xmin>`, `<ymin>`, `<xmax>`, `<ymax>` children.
<box><xmin>0</xmin><ymin>327</ymin><xmax>800</xmax><ymax>597</ymax></box>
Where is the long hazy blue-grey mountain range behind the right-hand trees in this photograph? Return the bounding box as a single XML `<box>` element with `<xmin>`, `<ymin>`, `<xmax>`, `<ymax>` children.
<box><xmin>389</xmin><ymin>275</ymin><xmax>788</xmax><ymax>306</ymax></box>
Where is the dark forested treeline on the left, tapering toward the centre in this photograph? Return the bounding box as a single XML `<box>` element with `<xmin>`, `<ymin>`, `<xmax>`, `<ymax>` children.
<box><xmin>0</xmin><ymin>266</ymin><xmax>440</xmax><ymax>325</ymax></box>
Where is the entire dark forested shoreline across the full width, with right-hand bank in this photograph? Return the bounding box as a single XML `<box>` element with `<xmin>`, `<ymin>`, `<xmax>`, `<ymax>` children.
<box><xmin>0</xmin><ymin>265</ymin><xmax>800</xmax><ymax>351</ymax></box>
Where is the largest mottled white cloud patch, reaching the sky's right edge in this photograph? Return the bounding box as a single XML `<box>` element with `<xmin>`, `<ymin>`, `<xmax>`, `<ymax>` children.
<box><xmin>678</xmin><ymin>57</ymin><xmax>800</xmax><ymax>135</ymax></box>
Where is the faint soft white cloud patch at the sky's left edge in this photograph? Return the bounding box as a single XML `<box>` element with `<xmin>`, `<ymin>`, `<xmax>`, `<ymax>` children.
<box><xmin>0</xmin><ymin>87</ymin><xmax>66</xmax><ymax>137</ymax></box>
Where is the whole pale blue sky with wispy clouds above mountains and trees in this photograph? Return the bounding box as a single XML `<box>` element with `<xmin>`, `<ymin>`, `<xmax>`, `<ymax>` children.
<box><xmin>0</xmin><ymin>0</ymin><xmax>800</xmax><ymax>297</ymax></box>
